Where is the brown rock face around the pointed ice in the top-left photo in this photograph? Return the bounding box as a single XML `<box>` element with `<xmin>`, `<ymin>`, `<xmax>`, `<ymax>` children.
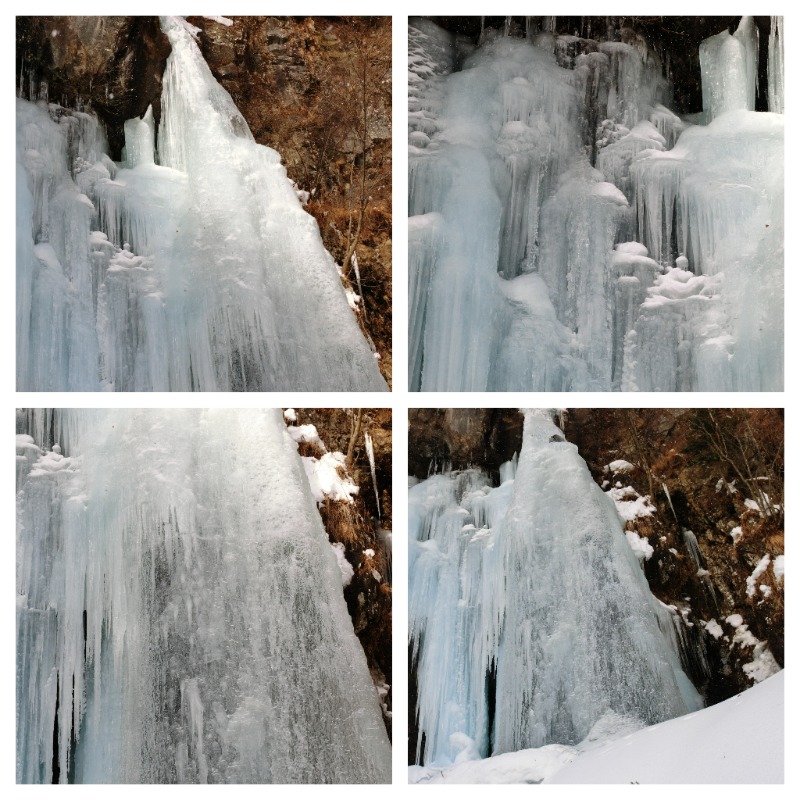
<box><xmin>16</xmin><ymin>17</ymin><xmax>392</xmax><ymax>382</ymax></box>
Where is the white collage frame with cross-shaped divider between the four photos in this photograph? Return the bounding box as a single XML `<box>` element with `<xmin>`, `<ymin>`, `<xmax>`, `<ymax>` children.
<box><xmin>6</xmin><ymin>0</ymin><xmax>800</xmax><ymax>797</ymax></box>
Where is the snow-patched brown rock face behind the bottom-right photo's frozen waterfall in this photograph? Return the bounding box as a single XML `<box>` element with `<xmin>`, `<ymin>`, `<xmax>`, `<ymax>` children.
<box><xmin>409</xmin><ymin>409</ymin><xmax>784</xmax><ymax>763</ymax></box>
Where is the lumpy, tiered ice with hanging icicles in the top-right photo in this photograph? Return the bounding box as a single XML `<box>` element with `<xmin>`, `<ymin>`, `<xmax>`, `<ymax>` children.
<box><xmin>408</xmin><ymin>17</ymin><xmax>784</xmax><ymax>391</ymax></box>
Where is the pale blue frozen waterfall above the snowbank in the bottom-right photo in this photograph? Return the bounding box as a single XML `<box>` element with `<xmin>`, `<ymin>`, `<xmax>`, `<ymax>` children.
<box><xmin>409</xmin><ymin>411</ymin><xmax>702</xmax><ymax>765</ymax></box>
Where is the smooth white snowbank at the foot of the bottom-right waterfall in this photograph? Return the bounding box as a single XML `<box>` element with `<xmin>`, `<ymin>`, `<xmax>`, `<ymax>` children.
<box><xmin>408</xmin><ymin>671</ymin><xmax>784</xmax><ymax>784</ymax></box>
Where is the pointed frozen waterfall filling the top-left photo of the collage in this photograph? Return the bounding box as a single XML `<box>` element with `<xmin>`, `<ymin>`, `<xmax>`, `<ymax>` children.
<box><xmin>17</xmin><ymin>18</ymin><xmax>387</xmax><ymax>391</ymax></box>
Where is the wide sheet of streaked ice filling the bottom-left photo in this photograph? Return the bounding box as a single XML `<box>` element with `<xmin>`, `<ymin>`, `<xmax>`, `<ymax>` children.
<box><xmin>17</xmin><ymin>409</ymin><xmax>391</xmax><ymax>783</ymax></box>
